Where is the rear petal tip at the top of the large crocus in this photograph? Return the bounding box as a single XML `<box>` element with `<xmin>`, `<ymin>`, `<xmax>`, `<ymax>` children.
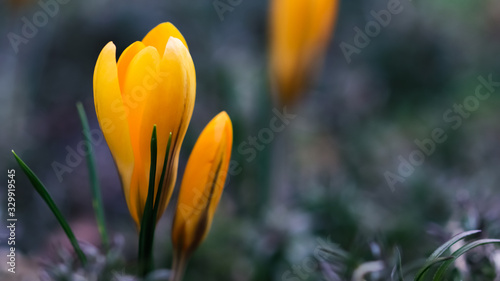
<box><xmin>142</xmin><ymin>22</ymin><xmax>188</xmax><ymax>56</ymax></box>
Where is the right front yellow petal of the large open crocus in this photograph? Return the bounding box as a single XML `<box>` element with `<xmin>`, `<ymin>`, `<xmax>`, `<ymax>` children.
<box><xmin>139</xmin><ymin>37</ymin><xmax>196</xmax><ymax>222</ymax></box>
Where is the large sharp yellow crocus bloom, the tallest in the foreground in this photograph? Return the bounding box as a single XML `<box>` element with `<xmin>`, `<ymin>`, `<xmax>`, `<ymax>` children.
<box><xmin>94</xmin><ymin>22</ymin><xmax>196</xmax><ymax>228</ymax></box>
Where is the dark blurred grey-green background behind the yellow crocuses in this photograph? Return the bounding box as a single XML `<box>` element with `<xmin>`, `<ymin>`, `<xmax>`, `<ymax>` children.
<box><xmin>0</xmin><ymin>0</ymin><xmax>500</xmax><ymax>281</ymax></box>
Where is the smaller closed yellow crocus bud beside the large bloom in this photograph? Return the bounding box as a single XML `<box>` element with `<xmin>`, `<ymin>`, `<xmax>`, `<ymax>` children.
<box><xmin>172</xmin><ymin>112</ymin><xmax>233</xmax><ymax>256</ymax></box>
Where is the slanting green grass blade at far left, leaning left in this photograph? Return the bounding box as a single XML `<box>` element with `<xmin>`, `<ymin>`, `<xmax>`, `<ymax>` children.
<box><xmin>12</xmin><ymin>150</ymin><xmax>87</xmax><ymax>266</ymax></box>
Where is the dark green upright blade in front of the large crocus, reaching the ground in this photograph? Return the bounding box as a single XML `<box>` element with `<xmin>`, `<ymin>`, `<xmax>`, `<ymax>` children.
<box><xmin>139</xmin><ymin>125</ymin><xmax>158</xmax><ymax>277</ymax></box>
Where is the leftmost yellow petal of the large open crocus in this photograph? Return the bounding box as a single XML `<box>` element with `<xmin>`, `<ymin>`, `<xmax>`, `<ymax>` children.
<box><xmin>94</xmin><ymin>42</ymin><xmax>134</xmax><ymax>212</ymax></box>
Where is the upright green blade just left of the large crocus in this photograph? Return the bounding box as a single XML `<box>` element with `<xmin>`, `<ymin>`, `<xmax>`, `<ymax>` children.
<box><xmin>76</xmin><ymin>102</ymin><xmax>109</xmax><ymax>249</ymax></box>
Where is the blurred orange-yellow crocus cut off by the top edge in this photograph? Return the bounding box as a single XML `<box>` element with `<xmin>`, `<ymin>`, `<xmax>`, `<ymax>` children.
<box><xmin>270</xmin><ymin>0</ymin><xmax>339</xmax><ymax>105</ymax></box>
